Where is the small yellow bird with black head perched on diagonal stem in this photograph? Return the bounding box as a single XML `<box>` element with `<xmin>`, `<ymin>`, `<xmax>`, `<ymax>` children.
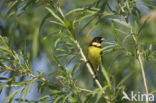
<box><xmin>88</xmin><ymin>37</ymin><xmax>104</xmax><ymax>79</ymax></box>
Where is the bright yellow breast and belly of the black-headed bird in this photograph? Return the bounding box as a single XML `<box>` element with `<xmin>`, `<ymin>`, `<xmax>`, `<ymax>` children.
<box><xmin>88</xmin><ymin>43</ymin><xmax>101</xmax><ymax>69</ymax></box>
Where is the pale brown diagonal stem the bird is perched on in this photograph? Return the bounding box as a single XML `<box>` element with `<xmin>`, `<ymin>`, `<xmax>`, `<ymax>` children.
<box><xmin>74</xmin><ymin>40</ymin><xmax>102</xmax><ymax>89</ymax></box>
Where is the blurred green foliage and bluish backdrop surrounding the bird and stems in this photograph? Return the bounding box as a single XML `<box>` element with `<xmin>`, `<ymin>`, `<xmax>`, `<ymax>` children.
<box><xmin>0</xmin><ymin>0</ymin><xmax>156</xmax><ymax>103</ymax></box>
